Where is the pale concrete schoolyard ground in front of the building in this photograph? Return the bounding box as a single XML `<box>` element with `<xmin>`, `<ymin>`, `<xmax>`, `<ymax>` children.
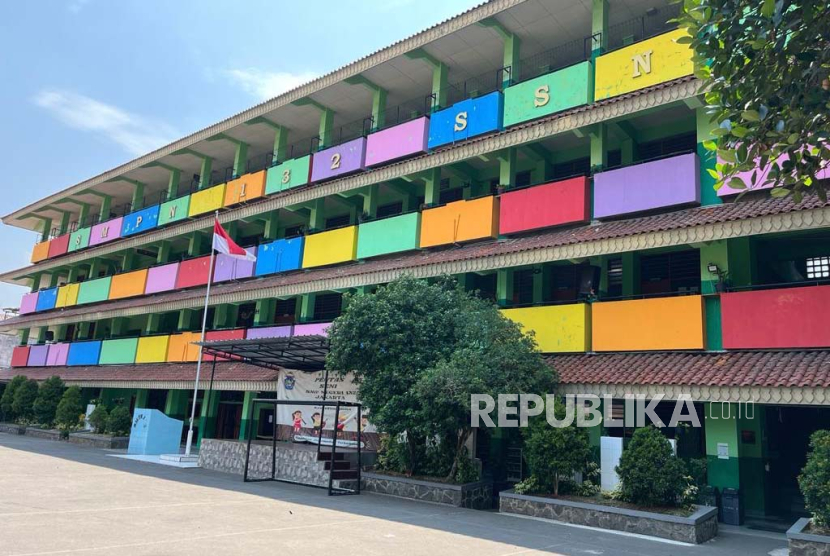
<box><xmin>0</xmin><ymin>433</ymin><xmax>787</xmax><ymax>556</ymax></box>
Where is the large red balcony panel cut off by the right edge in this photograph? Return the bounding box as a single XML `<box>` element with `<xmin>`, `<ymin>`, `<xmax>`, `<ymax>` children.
<box><xmin>721</xmin><ymin>286</ymin><xmax>830</xmax><ymax>349</ymax></box>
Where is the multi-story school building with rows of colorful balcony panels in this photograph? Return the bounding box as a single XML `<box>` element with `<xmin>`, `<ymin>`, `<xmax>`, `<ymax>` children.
<box><xmin>0</xmin><ymin>0</ymin><xmax>830</xmax><ymax>516</ymax></box>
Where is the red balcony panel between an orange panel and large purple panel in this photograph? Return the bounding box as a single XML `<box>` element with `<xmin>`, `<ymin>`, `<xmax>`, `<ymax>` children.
<box><xmin>499</xmin><ymin>177</ymin><xmax>591</xmax><ymax>234</ymax></box>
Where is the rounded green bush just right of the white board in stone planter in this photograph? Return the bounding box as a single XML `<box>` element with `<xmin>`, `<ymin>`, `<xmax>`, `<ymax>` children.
<box><xmin>617</xmin><ymin>426</ymin><xmax>689</xmax><ymax>507</ymax></box>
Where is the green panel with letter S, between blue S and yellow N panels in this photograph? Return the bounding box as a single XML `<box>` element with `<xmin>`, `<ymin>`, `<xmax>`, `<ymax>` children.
<box><xmin>504</xmin><ymin>62</ymin><xmax>594</xmax><ymax>127</ymax></box>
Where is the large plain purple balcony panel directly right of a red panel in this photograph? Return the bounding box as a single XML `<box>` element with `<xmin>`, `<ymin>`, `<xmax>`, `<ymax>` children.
<box><xmin>594</xmin><ymin>153</ymin><xmax>700</xmax><ymax>218</ymax></box>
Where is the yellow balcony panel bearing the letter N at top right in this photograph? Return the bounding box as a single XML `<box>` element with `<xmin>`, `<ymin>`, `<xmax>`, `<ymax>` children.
<box><xmin>594</xmin><ymin>29</ymin><xmax>694</xmax><ymax>100</ymax></box>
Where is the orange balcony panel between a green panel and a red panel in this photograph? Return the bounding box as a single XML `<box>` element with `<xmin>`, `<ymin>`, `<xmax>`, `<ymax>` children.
<box><xmin>421</xmin><ymin>197</ymin><xmax>499</xmax><ymax>247</ymax></box>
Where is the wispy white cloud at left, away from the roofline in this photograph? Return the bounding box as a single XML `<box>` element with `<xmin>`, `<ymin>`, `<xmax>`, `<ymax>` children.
<box><xmin>34</xmin><ymin>90</ymin><xmax>179</xmax><ymax>156</ymax></box>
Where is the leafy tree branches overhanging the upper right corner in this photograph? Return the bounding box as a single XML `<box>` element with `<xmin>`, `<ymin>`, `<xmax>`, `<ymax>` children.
<box><xmin>678</xmin><ymin>0</ymin><xmax>830</xmax><ymax>202</ymax></box>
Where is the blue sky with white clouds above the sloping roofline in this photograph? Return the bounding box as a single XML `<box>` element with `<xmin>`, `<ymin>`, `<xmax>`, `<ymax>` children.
<box><xmin>0</xmin><ymin>0</ymin><xmax>480</xmax><ymax>307</ymax></box>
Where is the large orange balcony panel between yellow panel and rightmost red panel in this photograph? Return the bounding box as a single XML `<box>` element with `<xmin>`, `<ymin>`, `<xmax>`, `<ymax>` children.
<box><xmin>591</xmin><ymin>295</ymin><xmax>705</xmax><ymax>351</ymax></box>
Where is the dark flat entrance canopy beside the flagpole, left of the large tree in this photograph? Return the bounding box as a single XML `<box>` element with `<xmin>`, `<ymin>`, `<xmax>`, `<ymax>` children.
<box><xmin>198</xmin><ymin>335</ymin><xmax>329</xmax><ymax>372</ymax></box>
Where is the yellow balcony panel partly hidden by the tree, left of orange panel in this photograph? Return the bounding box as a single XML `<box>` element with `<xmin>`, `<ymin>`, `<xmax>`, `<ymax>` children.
<box><xmin>502</xmin><ymin>303</ymin><xmax>591</xmax><ymax>353</ymax></box>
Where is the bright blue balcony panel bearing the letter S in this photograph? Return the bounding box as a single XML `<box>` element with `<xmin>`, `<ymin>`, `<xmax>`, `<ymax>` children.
<box><xmin>427</xmin><ymin>91</ymin><xmax>504</xmax><ymax>149</ymax></box>
